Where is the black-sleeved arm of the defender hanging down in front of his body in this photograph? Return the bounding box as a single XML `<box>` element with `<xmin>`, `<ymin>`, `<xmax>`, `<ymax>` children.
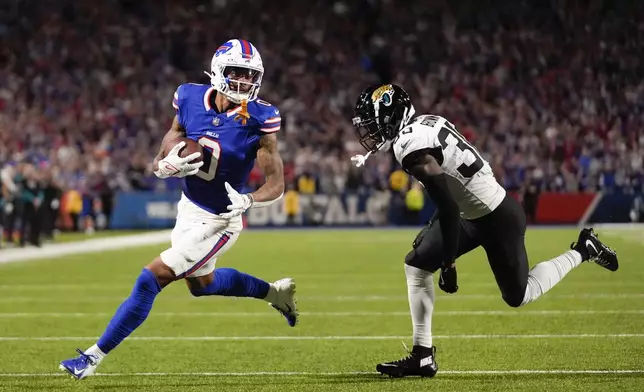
<box><xmin>402</xmin><ymin>150</ymin><xmax>461</xmax><ymax>267</ymax></box>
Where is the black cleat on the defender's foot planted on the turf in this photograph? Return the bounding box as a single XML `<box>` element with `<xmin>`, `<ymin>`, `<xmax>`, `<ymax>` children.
<box><xmin>376</xmin><ymin>346</ymin><xmax>438</xmax><ymax>378</ymax></box>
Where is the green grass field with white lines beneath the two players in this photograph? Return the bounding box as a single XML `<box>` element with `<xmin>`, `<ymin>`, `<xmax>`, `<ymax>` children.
<box><xmin>0</xmin><ymin>229</ymin><xmax>644</xmax><ymax>392</ymax></box>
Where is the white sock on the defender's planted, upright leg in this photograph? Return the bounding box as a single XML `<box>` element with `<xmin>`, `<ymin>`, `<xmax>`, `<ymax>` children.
<box><xmin>405</xmin><ymin>264</ymin><xmax>434</xmax><ymax>347</ymax></box>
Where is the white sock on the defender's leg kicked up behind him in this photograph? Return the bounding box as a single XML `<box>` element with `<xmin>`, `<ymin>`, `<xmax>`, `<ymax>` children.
<box><xmin>521</xmin><ymin>250</ymin><xmax>582</xmax><ymax>306</ymax></box>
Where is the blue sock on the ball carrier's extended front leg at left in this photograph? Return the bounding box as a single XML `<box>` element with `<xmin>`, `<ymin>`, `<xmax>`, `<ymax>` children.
<box><xmin>96</xmin><ymin>269</ymin><xmax>161</xmax><ymax>354</ymax></box>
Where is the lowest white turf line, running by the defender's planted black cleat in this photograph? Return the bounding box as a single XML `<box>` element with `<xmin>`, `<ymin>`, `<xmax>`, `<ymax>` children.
<box><xmin>0</xmin><ymin>369</ymin><xmax>644</xmax><ymax>377</ymax></box>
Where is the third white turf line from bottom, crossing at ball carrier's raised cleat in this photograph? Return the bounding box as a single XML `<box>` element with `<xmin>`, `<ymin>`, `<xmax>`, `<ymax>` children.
<box><xmin>0</xmin><ymin>309</ymin><xmax>644</xmax><ymax>319</ymax></box>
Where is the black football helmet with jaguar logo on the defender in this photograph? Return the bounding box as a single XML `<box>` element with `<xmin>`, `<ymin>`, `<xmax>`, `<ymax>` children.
<box><xmin>353</xmin><ymin>84</ymin><xmax>414</xmax><ymax>152</ymax></box>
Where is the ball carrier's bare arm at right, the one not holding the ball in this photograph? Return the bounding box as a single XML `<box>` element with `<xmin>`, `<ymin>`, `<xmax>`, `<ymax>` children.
<box><xmin>251</xmin><ymin>134</ymin><xmax>284</xmax><ymax>203</ymax></box>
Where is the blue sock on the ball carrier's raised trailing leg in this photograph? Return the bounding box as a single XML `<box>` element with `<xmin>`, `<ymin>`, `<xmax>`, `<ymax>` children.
<box><xmin>192</xmin><ymin>268</ymin><xmax>269</xmax><ymax>299</ymax></box>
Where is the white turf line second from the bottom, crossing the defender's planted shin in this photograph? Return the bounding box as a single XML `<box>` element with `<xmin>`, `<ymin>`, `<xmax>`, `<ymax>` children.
<box><xmin>0</xmin><ymin>333</ymin><xmax>644</xmax><ymax>342</ymax></box>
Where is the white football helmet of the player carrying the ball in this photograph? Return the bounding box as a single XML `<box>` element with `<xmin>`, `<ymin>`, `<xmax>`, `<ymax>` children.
<box><xmin>204</xmin><ymin>39</ymin><xmax>264</xmax><ymax>104</ymax></box>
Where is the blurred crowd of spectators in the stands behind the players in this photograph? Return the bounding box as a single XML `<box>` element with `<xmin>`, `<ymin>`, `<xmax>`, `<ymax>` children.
<box><xmin>0</xmin><ymin>0</ymin><xmax>644</xmax><ymax>239</ymax></box>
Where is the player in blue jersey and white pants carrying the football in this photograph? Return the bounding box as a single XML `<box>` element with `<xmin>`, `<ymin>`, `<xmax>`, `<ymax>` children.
<box><xmin>60</xmin><ymin>39</ymin><xmax>298</xmax><ymax>379</ymax></box>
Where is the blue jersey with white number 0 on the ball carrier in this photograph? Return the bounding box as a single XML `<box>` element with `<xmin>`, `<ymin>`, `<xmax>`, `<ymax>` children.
<box><xmin>172</xmin><ymin>83</ymin><xmax>281</xmax><ymax>214</ymax></box>
